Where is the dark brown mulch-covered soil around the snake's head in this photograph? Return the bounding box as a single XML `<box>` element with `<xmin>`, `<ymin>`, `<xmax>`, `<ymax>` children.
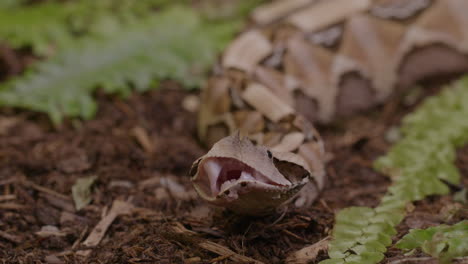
<box><xmin>0</xmin><ymin>54</ymin><xmax>468</xmax><ymax>263</ymax></box>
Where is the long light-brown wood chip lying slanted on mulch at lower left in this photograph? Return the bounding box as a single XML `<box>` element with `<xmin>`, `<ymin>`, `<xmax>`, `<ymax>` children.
<box><xmin>83</xmin><ymin>200</ymin><xmax>133</xmax><ymax>247</ymax></box>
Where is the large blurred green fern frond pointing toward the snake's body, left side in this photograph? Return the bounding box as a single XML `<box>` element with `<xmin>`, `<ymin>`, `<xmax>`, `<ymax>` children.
<box><xmin>0</xmin><ymin>7</ymin><xmax>237</xmax><ymax>123</ymax></box>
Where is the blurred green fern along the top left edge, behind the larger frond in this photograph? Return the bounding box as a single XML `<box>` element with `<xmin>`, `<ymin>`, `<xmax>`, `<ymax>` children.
<box><xmin>0</xmin><ymin>0</ymin><xmax>181</xmax><ymax>55</ymax></box>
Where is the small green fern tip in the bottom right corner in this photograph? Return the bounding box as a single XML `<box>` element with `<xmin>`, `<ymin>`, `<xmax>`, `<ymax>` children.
<box><xmin>395</xmin><ymin>220</ymin><xmax>468</xmax><ymax>263</ymax></box>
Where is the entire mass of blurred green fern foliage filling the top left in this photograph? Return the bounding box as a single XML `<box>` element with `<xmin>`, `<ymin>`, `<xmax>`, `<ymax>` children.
<box><xmin>0</xmin><ymin>0</ymin><xmax>263</xmax><ymax>124</ymax></box>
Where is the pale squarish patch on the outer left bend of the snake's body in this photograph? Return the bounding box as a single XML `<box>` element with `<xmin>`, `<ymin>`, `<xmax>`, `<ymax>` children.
<box><xmin>222</xmin><ymin>30</ymin><xmax>273</xmax><ymax>74</ymax></box>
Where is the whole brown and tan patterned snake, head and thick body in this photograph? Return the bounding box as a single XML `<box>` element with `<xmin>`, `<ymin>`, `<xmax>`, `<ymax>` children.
<box><xmin>191</xmin><ymin>0</ymin><xmax>468</xmax><ymax>214</ymax></box>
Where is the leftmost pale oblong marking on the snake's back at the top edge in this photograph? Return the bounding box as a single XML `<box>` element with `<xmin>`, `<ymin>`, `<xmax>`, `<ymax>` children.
<box><xmin>252</xmin><ymin>0</ymin><xmax>313</xmax><ymax>25</ymax></box>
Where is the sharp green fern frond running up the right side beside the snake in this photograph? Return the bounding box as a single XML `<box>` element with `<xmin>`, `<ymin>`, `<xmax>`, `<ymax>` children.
<box><xmin>320</xmin><ymin>77</ymin><xmax>468</xmax><ymax>264</ymax></box>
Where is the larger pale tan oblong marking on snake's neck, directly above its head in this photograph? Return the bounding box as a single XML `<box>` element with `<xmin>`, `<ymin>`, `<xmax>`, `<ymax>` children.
<box><xmin>242</xmin><ymin>83</ymin><xmax>294</xmax><ymax>122</ymax></box>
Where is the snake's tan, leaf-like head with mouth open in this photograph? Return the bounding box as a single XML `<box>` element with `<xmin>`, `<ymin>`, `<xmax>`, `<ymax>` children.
<box><xmin>190</xmin><ymin>133</ymin><xmax>310</xmax><ymax>215</ymax></box>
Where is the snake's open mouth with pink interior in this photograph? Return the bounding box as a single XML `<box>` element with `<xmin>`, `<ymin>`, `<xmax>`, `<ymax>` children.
<box><xmin>200</xmin><ymin>158</ymin><xmax>283</xmax><ymax>196</ymax></box>
